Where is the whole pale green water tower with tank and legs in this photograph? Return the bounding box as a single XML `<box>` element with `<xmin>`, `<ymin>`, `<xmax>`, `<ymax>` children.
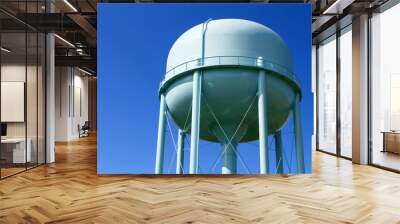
<box><xmin>155</xmin><ymin>19</ymin><xmax>304</xmax><ymax>174</ymax></box>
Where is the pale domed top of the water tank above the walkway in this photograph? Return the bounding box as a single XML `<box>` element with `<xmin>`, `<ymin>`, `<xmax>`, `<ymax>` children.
<box><xmin>164</xmin><ymin>19</ymin><xmax>293</xmax><ymax>81</ymax></box>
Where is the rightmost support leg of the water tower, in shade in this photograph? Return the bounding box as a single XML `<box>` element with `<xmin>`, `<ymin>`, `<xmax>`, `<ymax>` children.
<box><xmin>293</xmin><ymin>94</ymin><xmax>305</xmax><ymax>173</ymax></box>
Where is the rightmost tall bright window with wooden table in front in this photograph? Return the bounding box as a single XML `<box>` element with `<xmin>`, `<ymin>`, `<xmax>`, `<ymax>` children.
<box><xmin>370</xmin><ymin>4</ymin><xmax>400</xmax><ymax>170</ymax></box>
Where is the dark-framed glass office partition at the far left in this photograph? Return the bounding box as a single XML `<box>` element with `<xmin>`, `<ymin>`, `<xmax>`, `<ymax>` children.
<box><xmin>0</xmin><ymin>1</ymin><xmax>46</xmax><ymax>178</ymax></box>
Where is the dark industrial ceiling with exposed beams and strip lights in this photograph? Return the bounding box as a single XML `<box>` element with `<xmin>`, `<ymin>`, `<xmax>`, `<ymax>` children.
<box><xmin>0</xmin><ymin>0</ymin><xmax>386</xmax><ymax>73</ymax></box>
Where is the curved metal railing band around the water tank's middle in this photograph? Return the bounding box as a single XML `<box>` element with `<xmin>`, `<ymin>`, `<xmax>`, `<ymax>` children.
<box><xmin>165</xmin><ymin>56</ymin><xmax>300</xmax><ymax>85</ymax></box>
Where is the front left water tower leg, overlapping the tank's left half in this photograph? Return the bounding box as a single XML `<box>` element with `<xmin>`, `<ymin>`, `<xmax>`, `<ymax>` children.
<box><xmin>189</xmin><ymin>71</ymin><xmax>201</xmax><ymax>174</ymax></box>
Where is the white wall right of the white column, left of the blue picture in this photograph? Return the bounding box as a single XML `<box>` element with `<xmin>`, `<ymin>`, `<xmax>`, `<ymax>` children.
<box><xmin>55</xmin><ymin>67</ymin><xmax>88</xmax><ymax>141</ymax></box>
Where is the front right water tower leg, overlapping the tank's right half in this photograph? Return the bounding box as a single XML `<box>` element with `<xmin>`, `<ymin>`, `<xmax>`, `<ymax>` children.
<box><xmin>258</xmin><ymin>70</ymin><xmax>268</xmax><ymax>174</ymax></box>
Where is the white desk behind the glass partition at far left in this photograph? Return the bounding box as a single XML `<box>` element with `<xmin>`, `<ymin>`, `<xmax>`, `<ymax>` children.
<box><xmin>1</xmin><ymin>138</ymin><xmax>32</xmax><ymax>163</ymax></box>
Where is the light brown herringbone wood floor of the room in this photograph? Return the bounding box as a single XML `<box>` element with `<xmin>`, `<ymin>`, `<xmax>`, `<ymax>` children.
<box><xmin>0</xmin><ymin>134</ymin><xmax>400</xmax><ymax>224</ymax></box>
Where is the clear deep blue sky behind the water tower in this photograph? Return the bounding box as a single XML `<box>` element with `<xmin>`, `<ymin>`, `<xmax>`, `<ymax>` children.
<box><xmin>98</xmin><ymin>3</ymin><xmax>313</xmax><ymax>174</ymax></box>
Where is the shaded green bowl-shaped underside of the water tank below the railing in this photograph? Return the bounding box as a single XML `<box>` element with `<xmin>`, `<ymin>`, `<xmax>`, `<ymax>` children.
<box><xmin>165</xmin><ymin>68</ymin><xmax>295</xmax><ymax>142</ymax></box>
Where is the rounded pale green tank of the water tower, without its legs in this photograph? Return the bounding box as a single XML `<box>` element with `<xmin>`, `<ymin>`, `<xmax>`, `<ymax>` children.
<box><xmin>160</xmin><ymin>19</ymin><xmax>300</xmax><ymax>142</ymax></box>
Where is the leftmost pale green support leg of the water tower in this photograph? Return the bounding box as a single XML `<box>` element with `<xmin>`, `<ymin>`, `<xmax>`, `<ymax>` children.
<box><xmin>155</xmin><ymin>94</ymin><xmax>165</xmax><ymax>174</ymax></box>
